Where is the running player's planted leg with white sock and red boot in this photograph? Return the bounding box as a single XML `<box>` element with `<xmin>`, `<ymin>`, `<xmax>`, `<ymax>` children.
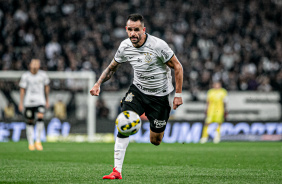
<box><xmin>103</xmin><ymin>86</ymin><xmax>144</xmax><ymax>179</ymax></box>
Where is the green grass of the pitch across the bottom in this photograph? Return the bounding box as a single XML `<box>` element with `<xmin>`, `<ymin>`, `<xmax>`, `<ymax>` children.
<box><xmin>0</xmin><ymin>141</ymin><xmax>282</xmax><ymax>184</ymax></box>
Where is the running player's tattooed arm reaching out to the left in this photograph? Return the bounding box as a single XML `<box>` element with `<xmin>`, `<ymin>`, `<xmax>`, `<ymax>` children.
<box><xmin>90</xmin><ymin>59</ymin><xmax>120</xmax><ymax>96</ymax></box>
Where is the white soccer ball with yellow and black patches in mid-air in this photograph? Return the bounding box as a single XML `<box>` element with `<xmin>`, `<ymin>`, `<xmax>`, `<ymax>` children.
<box><xmin>116</xmin><ymin>111</ymin><xmax>141</xmax><ymax>136</ymax></box>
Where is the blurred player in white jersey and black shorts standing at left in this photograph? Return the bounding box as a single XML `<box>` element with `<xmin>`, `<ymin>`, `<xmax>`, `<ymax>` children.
<box><xmin>19</xmin><ymin>59</ymin><xmax>50</xmax><ymax>151</ymax></box>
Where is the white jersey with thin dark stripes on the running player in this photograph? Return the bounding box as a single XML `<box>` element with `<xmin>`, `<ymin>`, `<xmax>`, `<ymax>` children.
<box><xmin>114</xmin><ymin>33</ymin><xmax>174</xmax><ymax>96</ymax></box>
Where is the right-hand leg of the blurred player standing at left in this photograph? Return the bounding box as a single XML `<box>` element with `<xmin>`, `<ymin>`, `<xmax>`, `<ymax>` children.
<box><xmin>35</xmin><ymin>106</ymin><xmax>45</xmax><ymax>151</ymax></box>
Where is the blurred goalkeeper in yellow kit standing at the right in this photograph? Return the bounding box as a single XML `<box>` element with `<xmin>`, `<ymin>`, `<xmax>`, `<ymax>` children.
<box><xmin>200</xmin><ymin>81</ymin><xmax>227</xmax><ymax>144</ymax></box>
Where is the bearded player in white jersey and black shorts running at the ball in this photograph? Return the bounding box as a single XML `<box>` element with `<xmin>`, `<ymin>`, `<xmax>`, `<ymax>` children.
<box><xmin>90</xmin><ymin>14</ymin><xmax>183</xmax><ymax>179</ymax></box>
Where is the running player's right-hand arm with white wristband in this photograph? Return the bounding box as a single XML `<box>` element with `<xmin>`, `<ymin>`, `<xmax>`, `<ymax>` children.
<box><xmin>166</xmin><ymin>55</ymin><xmax>183</xmax><ymax>109</ymax></box>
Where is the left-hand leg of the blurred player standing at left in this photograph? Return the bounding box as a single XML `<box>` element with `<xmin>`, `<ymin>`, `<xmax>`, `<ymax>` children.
<box><xmin>24</xmin><ymin>107</ymin><xmax>35</xmax><ymax>151</ymax></box>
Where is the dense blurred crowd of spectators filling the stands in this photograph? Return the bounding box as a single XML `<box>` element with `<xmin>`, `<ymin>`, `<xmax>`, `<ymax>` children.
<box><xmin>0</xmin><ymin>0</ymin><xmax>282</xmax><ymax>93</ymax></box>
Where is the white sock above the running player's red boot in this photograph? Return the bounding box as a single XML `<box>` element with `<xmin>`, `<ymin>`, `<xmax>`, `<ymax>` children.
<box><xmin>114</xmin><ymin>137</ymin><xmax>129</xmax><ymax>173</ymax></box>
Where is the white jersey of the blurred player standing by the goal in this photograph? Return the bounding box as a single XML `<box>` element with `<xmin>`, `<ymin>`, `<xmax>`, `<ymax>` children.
<box><xmin>19</xmin><ymin>70</ymin><xmax>50</xmax><ymax>107</ymax></box>
